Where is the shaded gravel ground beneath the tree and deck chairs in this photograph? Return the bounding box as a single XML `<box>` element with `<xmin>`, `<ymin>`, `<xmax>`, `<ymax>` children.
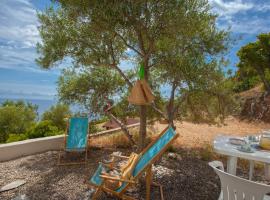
<box><xmin>0</xmin><ymin>149</ymin><xmax>268</xmax><ymax>200</ymax></box>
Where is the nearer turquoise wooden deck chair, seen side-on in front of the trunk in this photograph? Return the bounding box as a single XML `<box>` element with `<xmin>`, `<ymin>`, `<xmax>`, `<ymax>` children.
<box><xmin>87</xmin><ymin>127</ymin><xmax>178</xmax><ymax>200</ymax></box>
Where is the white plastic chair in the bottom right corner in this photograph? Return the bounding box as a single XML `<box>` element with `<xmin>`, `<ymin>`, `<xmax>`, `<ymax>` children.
<box><xmin>209</xmin><ymin>161</ymin><xmax>270</xmax><ymax>200</ymax></box>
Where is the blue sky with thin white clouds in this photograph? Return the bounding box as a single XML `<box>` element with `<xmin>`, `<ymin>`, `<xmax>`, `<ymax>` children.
<box><xmin>0</xmin><ymin>0</ymin><xmax>270</xmax><ymax>99</ymax></box>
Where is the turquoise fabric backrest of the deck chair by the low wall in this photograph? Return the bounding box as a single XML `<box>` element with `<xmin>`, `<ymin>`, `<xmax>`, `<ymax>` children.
<box><xmin>66</xmin><ymin>117</ymin><xmax>88</xmax><ymax>149</ymax></box>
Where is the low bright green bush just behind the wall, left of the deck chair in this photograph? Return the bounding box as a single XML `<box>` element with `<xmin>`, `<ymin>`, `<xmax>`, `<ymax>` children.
<box><xmin>27</xmin><ymin>120</ymin><xmax>63</xmax><ymax>139</ymax></box>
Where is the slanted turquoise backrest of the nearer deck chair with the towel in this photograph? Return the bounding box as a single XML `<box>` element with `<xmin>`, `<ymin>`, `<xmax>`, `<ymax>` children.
<box><xmin>117</xmin><ymin>126</ymin><xmax>178</xmax><ymax>192</ymax></box>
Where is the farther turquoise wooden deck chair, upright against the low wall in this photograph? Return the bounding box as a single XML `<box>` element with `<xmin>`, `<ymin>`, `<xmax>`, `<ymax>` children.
<box><xmin>58</xmin><ymin>117</ymin><xmax>88</xmax><ymax>165</ymax></box>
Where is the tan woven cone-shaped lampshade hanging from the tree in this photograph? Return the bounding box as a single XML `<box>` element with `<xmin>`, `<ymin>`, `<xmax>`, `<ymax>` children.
<box><xmin>128</xmin><ymin>79</ymin><xmax>155</xmax><ymax>105</ymax></box>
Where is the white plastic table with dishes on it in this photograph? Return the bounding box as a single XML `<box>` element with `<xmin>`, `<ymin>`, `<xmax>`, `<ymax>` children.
<box><xmin>214</xmin><ymin>136</ymin><xmax>270</xmax><ymax>180</ymax></box>
